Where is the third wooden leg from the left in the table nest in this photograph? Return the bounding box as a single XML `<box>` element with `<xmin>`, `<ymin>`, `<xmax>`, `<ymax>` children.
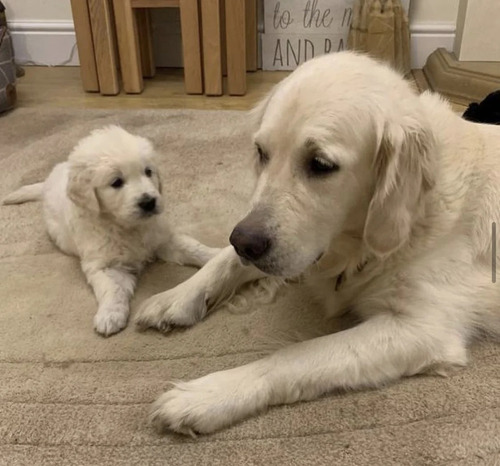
<box><xmin>113</xmin><ymin>0</ymin><xmax>144</xmax><ymax>94</ymax></box>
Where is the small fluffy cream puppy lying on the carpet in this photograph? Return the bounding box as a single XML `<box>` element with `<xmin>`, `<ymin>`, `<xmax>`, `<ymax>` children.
<box><xmin>3</xmin><ymin>126</ymin><xmax>219</xmax><ymax>336</ymax></box>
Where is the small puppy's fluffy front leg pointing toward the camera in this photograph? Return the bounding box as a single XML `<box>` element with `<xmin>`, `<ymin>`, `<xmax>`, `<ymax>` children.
<box><xmin>85</xmin><ymin>268</ymin><xmax>136</xmax><ymax>337</ymax></box>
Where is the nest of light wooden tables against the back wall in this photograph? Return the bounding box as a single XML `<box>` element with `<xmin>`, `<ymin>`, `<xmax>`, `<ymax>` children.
<box><xmin>71</xmin><ymin>0</ymin><xmax>257</xmax><ymax>95</ymax></box>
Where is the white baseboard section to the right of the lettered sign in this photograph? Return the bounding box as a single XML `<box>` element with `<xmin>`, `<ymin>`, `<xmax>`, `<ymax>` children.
<box><xmin>410</xmin><ymin>23</ymin><xmax>456</xmax><ymax>69</ymax></box>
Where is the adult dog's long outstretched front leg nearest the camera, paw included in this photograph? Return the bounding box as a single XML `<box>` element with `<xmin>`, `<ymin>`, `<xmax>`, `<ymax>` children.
<box><xmin>152</xmin><ymin>315</ymin><xmax>466</xmax><ymax>433</ymax></box>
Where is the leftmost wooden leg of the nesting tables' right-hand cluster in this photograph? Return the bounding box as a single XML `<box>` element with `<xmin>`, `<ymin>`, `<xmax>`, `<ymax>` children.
<box><xmin>179</xmin><ymin>0</ymin><xmax>203</xmax><ymax>94</ymax></box>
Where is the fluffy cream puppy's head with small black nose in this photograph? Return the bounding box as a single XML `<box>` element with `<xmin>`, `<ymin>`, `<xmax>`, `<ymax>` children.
<box><xmin>67</xmin><ymin>126</ymin><xmax>163</xmax><ymax>227</ymax></box>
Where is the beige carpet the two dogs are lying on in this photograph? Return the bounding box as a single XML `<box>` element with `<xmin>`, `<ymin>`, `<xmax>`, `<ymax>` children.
<box><xmin>0</xmin><ymin>110</ymin><xmax>500</xmax><ymax>466</ymax></box>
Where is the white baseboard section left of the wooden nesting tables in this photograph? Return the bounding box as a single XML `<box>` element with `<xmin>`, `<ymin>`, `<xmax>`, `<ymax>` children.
<box><xmin>8</xmin><ymin>21</ymin><xmax>80</xmax><ymax>66</ymax></box>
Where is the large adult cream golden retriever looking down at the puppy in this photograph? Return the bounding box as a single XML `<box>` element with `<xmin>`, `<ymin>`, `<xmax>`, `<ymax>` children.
<box><xmin>138</xmin><ymin>52</ymin><xmax>500</xmax><ymax>433</ymax></box>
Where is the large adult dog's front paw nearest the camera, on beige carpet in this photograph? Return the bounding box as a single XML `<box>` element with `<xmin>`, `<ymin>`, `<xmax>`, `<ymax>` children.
<box><xmin>151</xmin><ymin>366</ymin><xmax>269</xmax><ymax>436</ymax></box>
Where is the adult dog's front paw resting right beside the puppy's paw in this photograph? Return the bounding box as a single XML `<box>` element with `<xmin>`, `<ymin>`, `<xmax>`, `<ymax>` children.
<box><xmin>135</xmin><ymin>285</ymin><xmax>207</xmax><ymax>332</ymax></box>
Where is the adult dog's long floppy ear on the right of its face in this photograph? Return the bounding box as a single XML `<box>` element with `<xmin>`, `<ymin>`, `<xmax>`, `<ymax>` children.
<box><xmin>364</xmin><ymin>117</ymin><xmax>434</xmax><ymax>256</ymax></box>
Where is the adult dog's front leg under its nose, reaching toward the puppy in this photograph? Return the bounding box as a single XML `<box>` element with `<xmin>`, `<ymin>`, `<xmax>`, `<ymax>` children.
<box><xmin>135</xmin><ymin>246</ymin><xmax>266</xmax><ymax>331</ymax></box>
